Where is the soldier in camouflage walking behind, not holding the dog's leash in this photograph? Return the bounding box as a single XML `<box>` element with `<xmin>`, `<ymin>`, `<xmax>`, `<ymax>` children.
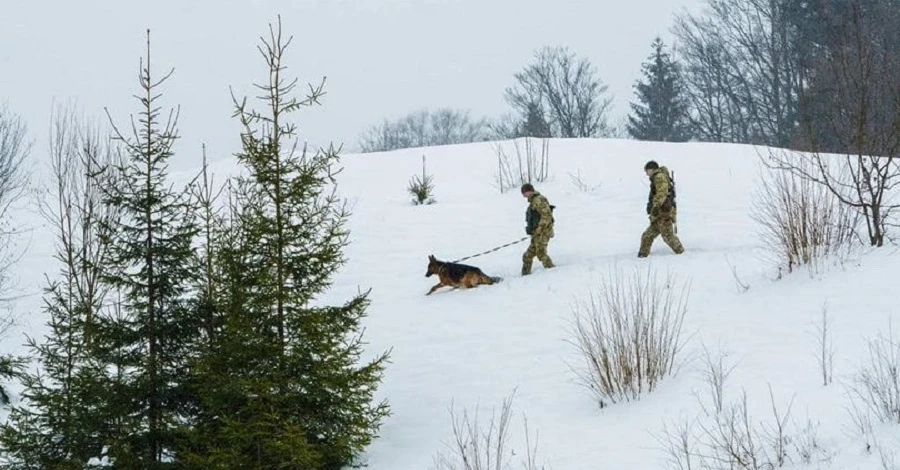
<box><xmin>638</xmin><ymin>160</ymin><xmax>684</xmax><ymax>258</ymax></box>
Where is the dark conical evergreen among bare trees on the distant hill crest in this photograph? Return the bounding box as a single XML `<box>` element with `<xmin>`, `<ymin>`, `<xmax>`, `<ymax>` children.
<box><xmin>627</xmin><ymin>37</ymin><xmax>690</xmax><ymax>142</ymax></box>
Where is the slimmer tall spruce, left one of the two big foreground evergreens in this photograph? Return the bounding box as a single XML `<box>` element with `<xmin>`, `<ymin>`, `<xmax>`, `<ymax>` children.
<box><xmin>94</xmin><ymin>31</ymin><xmax>200</xmax><ymax>469</ymax></box>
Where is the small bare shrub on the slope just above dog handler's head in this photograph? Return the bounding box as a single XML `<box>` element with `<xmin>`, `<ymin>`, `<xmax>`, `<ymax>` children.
<box><xmin>495</xmin><ymin>137</ymin><xmax>550</xmax><ymax>193</ymax></box>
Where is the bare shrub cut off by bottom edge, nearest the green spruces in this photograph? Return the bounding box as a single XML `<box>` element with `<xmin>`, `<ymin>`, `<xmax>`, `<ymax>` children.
<box><xmin>431</xmin><ymin>391</ymin><xmax>545</xmax><ymax>470</ymax></box>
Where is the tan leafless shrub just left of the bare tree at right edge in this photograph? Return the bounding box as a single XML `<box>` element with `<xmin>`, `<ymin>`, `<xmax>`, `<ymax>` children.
<box><xmin>751</xmin><ymin>150</ymin><xmax>858</xmax><ymax>273</ymax></box>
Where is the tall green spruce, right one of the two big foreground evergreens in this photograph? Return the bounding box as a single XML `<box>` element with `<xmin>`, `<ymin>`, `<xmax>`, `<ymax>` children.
<box><xmin>185</xmin><ymin>18</ymin><xmax>388</xmax><ymax>470</ymax></box>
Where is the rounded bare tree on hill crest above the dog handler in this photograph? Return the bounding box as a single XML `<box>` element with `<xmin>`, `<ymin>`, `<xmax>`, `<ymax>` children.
<box><xmin>506</xmin><ymin>46</ymin><xmax>612</xmax><ymax>137</ymax></box>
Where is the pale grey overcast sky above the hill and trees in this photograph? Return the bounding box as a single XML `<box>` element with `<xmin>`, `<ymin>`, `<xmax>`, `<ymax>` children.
<box><xmin>0</xmin><ymin>0</ymin><xmax>702</xmax><ymax>169</ymax></box>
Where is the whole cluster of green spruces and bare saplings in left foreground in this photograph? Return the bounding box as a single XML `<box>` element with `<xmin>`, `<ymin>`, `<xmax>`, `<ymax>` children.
<box><xmin>0</xmin><ymin>18</ymin><xmax>389</xmax><ymax>470</ymax></box>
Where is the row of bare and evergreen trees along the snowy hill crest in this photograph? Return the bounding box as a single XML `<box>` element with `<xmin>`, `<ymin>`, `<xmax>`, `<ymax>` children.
<box><xmin>359</xmin><ymin>0</ymin><xmax>900</xmax><ymax>158</ymax></box>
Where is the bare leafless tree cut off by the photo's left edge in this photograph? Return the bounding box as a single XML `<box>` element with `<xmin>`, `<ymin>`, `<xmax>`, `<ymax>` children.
<box><xmin>0</xmin><ymin>104</ymin><xmax>31</xmax><ymax>303</ymax></box>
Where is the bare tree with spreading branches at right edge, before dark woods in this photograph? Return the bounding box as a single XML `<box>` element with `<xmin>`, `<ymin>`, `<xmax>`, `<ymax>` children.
<box><xmin>771</xmin><ymin>0</ymin><xmax>900</xmax><ymax>246</ymax></box>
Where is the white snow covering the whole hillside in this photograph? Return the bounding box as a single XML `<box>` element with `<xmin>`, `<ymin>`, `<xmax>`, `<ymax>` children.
<box><xmin>2</xmin><ymin>139</ymin><xmax>900</xmax><ymax>470</ymax></box>
